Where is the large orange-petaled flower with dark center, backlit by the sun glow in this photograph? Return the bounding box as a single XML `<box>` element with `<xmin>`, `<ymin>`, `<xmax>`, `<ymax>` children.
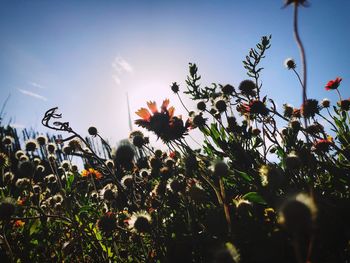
<box><xmin>135</xmin><ymin>99</ymin><xmax>191</xmax><ymax>142</ymax></box>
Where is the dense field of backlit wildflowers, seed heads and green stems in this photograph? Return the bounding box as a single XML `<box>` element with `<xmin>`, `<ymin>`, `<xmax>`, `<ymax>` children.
<box><xmin>0</xmin><ymin>1</ymin><xmax>350</xmax><ymax>263</ymax></box>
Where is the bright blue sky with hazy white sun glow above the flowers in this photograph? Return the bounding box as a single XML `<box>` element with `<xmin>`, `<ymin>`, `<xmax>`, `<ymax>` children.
<box><xmin>0</xmin><ymin>0</ymin><xmax>350</xmax><ymax>146</ymax></box>
